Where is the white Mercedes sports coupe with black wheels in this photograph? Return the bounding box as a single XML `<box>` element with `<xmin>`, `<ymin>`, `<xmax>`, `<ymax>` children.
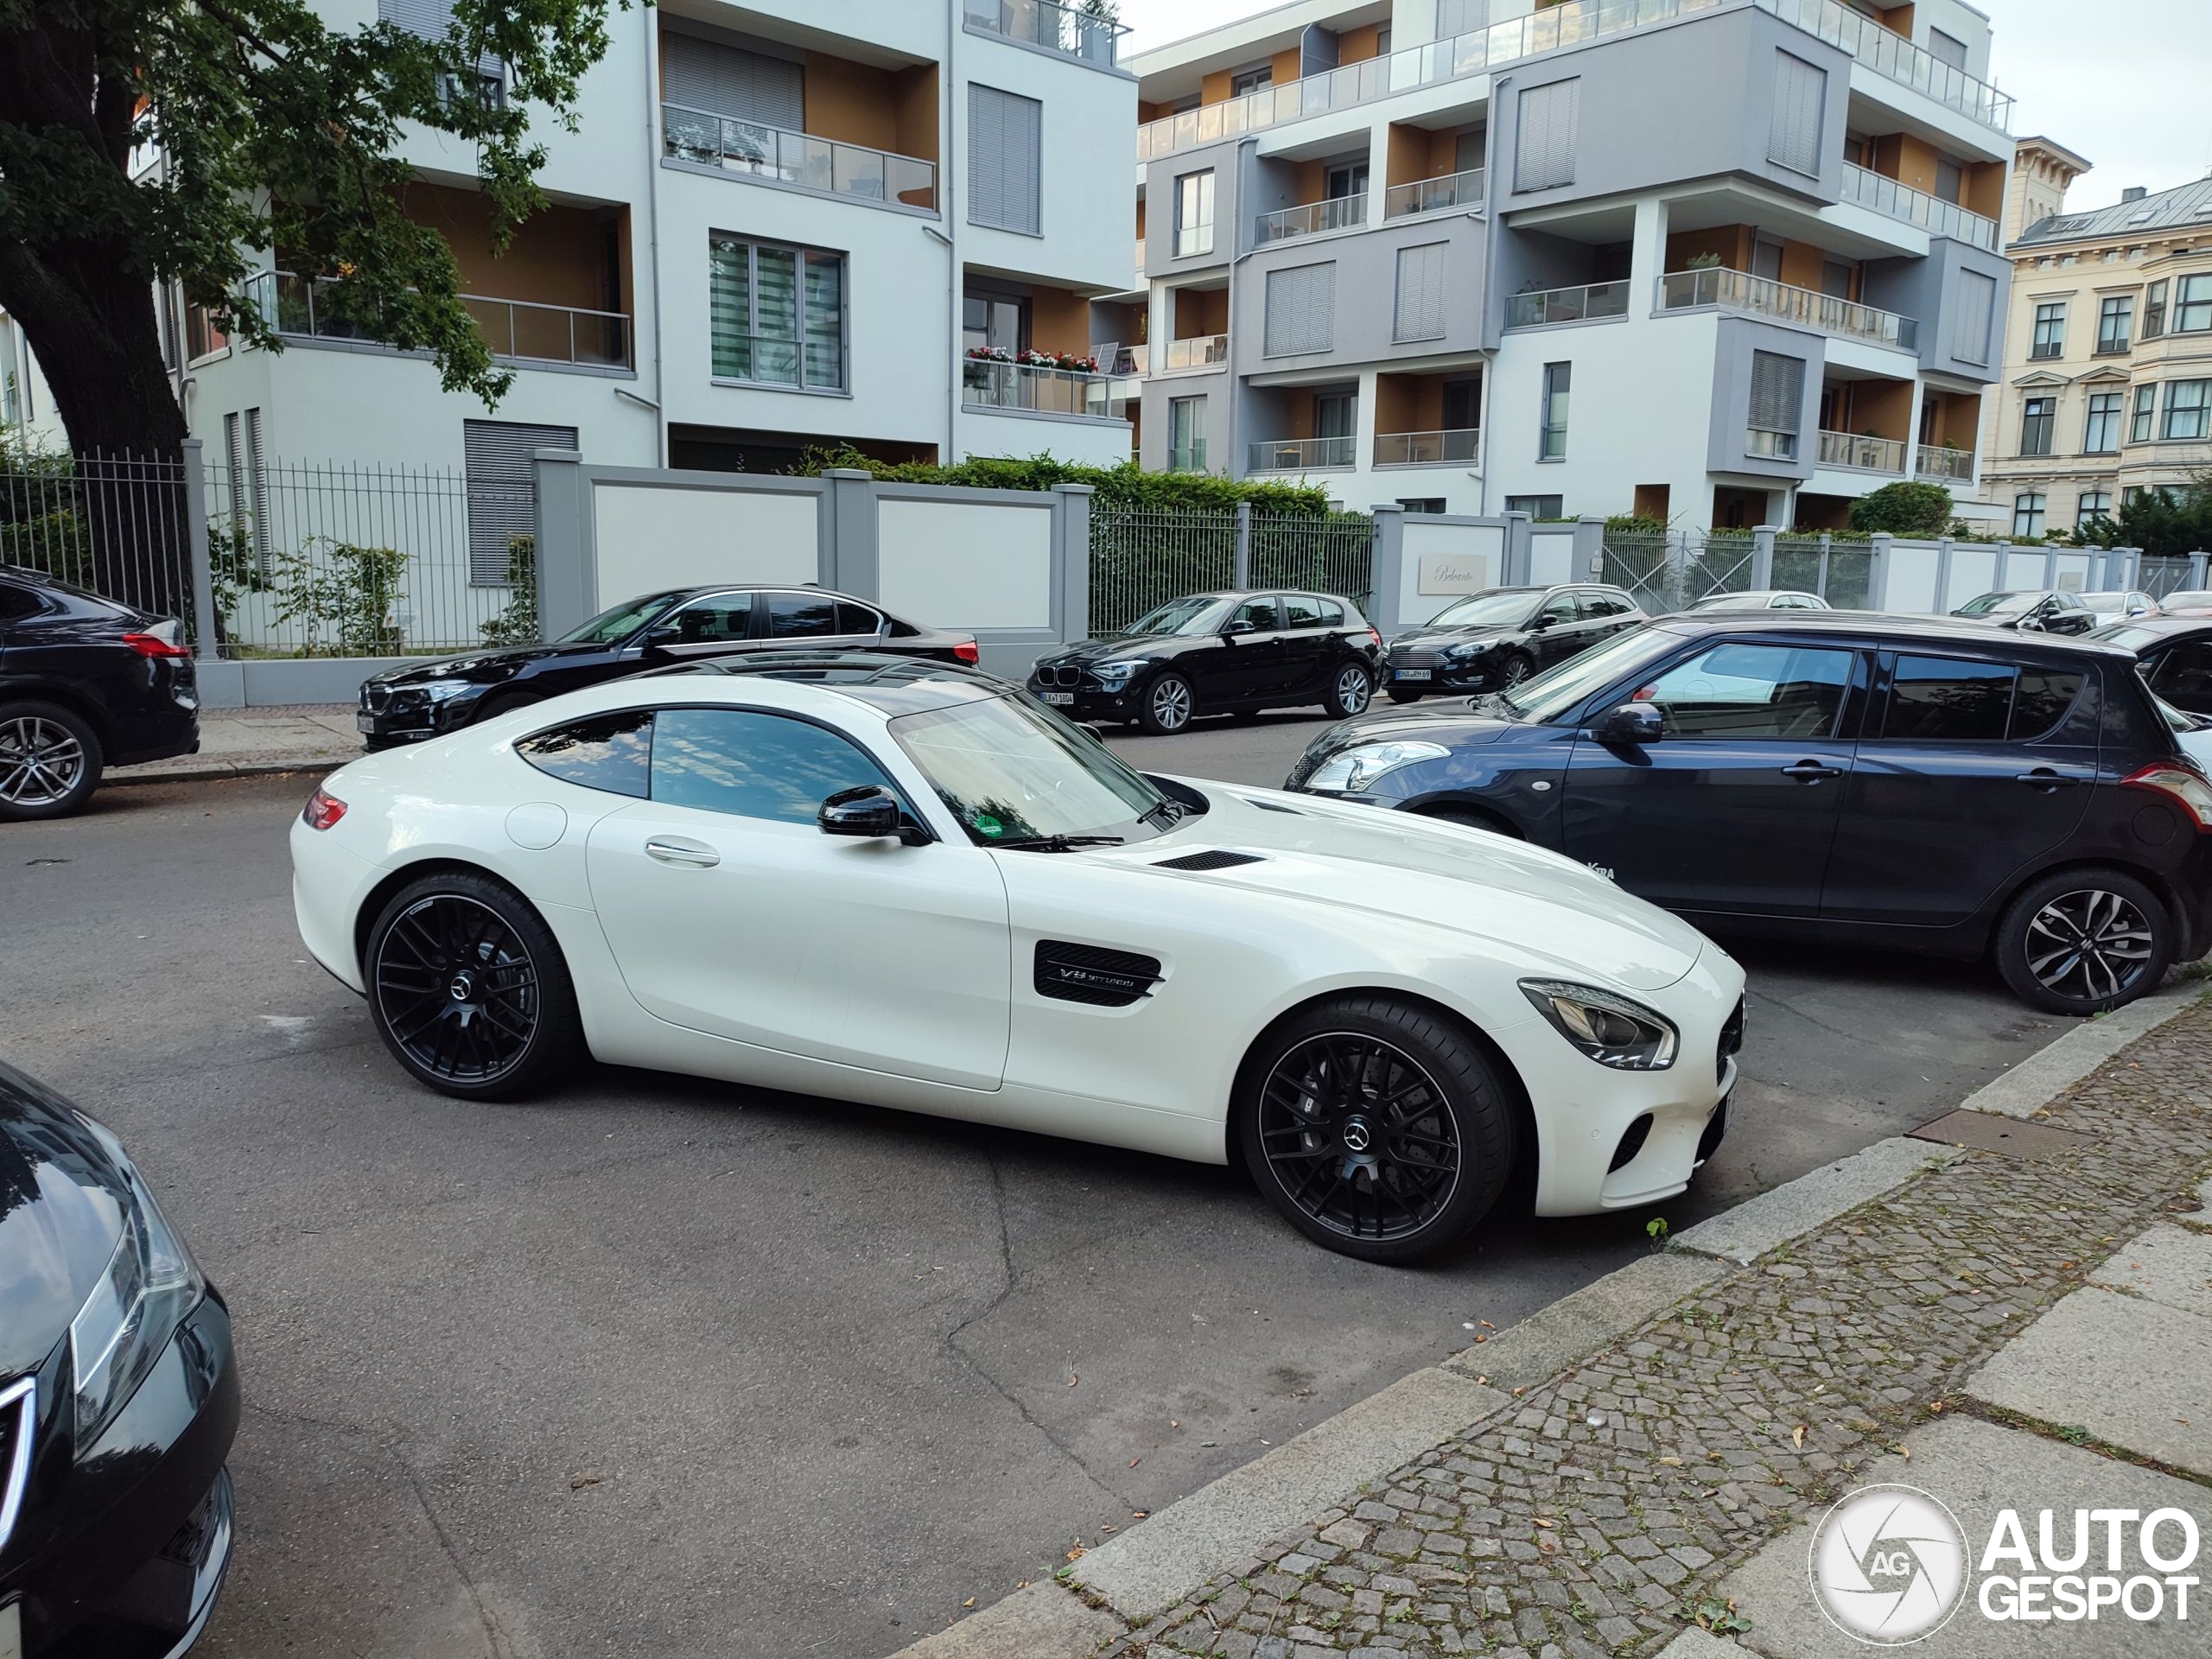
<box><xmin>292</xmin><ymin>657</ymin><xmax>1743</xmax><ymax>1261</ymax></box>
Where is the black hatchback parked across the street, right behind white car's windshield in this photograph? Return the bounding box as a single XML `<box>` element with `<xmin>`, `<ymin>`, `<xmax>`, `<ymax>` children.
<box><xmin>1028</xmin><ymin>588</ymin><xmax>1382</xmax><ymax>734</ymax></box>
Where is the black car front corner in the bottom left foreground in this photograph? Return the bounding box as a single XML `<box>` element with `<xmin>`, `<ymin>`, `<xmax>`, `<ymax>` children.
<box><xmin>0</xmin><ymin>1066</ymin><xmax>238</xmax><ymax>1659</ymax></box>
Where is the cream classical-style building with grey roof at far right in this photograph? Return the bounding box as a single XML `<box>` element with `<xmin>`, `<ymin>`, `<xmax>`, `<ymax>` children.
<box><xmin>1982</xmin><ymin>137</ymin><xmax>2212</xmax><ymax>536</ymax></box>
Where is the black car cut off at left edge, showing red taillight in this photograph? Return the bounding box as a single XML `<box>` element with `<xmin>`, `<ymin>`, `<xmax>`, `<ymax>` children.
<box><xmin>0</xmin><ymin>564</ymin><xmax>199</xmax><ymax>823</ymax></box>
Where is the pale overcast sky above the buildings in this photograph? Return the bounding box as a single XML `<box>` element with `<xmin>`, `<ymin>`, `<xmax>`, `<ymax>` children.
<box><xmin>1119</xmin><ymin>0</ymin><xmax>2212</xmax><ymax>213</ymax></box>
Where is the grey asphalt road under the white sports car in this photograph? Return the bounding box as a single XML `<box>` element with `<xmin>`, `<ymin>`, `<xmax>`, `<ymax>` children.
<box><xmin>0</xmin><ymin>716</ymin><xmax>2055</xmax><ymax>1659</ymax></box>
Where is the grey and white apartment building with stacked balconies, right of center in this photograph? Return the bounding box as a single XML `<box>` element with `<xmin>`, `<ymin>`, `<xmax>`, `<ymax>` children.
<box><xmin>1133</xmin><ymin>0</ymin><xmax>2013</xmax><ymax>526</ymax></box>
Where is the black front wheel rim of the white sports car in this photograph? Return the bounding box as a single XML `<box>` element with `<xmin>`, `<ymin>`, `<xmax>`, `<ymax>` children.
<box><xmin>1259</xmin><ymin>1031</ymin><xmax>1460</xmax><ymax>1241</ymax></box>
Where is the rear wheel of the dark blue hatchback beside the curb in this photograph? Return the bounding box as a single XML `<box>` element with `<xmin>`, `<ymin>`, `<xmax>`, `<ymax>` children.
<box><xmin>1991</xmin><ymin>868</ymin><xmax>2174</xmax><ymax>1015</ymax></box>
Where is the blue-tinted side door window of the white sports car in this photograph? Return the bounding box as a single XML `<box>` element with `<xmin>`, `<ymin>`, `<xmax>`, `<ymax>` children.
<box><xmin>652</xmin><ymin>708</ymin><xmax>896</xmax><ymax>823</ymax></box>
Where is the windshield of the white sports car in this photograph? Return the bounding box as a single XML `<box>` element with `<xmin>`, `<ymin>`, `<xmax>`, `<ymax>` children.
<box><xmin>889</xmin><ymin>696</ymin><xmax>1173</xmax><ymax>847</ymax></box>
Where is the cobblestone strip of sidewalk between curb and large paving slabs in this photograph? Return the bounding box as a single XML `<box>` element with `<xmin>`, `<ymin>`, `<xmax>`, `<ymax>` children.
<box><xmin>1102</xmin><ymin>1004</ymin><xmax>2212</xmax><ymax>1659</ymax></box>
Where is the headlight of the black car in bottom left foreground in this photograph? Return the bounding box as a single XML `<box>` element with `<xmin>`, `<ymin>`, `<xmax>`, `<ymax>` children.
<box><xmin>68</xmin><ymin>1119</ymin><xmax>208</xmax><ymax>1451</ymax></box>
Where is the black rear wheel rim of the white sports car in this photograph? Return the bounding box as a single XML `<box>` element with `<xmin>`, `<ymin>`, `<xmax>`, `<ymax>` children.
<box><xmin>376</xmin><ymin>893</ymin><xmax>540</xmax><ymax>1084</ymax></box>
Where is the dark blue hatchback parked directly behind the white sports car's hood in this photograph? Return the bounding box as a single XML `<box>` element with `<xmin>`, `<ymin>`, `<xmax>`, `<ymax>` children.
<box><xmin>1287</xmin><ymin>611</ymin><xmax>2212</xmax><ymax>1013</ymax></box>
